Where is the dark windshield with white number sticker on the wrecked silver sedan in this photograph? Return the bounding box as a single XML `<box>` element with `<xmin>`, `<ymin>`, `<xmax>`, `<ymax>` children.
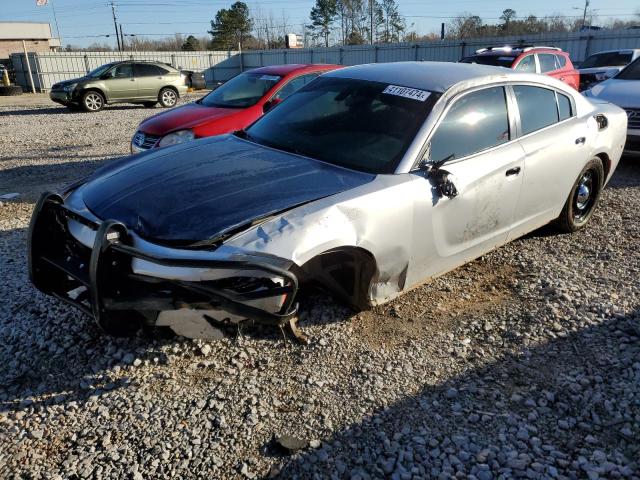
<box><xmin>246</xmin><ymin>77</ymin><xmax>437</xmax><ymax>173</ymax></box>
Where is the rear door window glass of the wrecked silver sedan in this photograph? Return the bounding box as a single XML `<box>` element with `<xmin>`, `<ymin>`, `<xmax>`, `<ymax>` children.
<box><xmin>513</xmin><ymin>85</ymin><xmax>558</xmax><ymax>135</ymax></box>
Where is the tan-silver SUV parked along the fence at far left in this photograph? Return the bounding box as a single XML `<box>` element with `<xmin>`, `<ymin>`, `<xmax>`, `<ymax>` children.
<box><xmin>49</xmin><ymin>61</ymin><xmax>188</xmax><ymax>112</ymax></box>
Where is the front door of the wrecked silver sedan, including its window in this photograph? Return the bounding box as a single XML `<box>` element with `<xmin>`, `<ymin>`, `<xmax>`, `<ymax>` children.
<box><xmin>427</xmin><ymin>86</ymin><xmax>524</xmax><ymax>262</ymax></box>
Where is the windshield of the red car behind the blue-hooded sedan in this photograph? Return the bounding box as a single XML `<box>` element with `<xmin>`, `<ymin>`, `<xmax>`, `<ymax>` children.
<box><xmin>200</xmin><ymin>72</ymin><xmax>282</xmax><ymax>108</ymax></box>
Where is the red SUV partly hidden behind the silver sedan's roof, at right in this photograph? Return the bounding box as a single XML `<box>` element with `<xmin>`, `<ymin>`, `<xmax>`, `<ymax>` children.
<box><xmin>461</xmin><ymin>45</ymin><xmax>580</xmax><ymax>90</ymax></box>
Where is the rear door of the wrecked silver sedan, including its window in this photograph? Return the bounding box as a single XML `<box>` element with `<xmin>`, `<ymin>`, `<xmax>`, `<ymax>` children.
<box><xmin>510</xmin><ymin>84</ymin><xmax>588</xmax><ymax>238</ymax></box>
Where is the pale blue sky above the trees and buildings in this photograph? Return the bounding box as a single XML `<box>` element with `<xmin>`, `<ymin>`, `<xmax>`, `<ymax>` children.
<box><xmin>0</xmin><ymin>0</ymin><xmax>640</xmax><ymax>46</ymax></box>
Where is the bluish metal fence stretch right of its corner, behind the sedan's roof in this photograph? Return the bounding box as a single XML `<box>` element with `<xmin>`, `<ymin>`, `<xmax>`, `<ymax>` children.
<box><xmin>242</xmin><ymin>30</ymin><xmax>640</xmax><ymax>69</ymax></box>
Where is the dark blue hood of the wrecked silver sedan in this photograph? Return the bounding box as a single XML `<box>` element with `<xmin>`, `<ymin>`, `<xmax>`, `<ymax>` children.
<box><xmin>79</xmin><ymin>135</ymin><xmax>374</xmax><ymax>244</ymax></box>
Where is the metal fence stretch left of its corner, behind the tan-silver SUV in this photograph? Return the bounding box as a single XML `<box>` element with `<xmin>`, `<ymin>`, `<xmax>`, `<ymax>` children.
<box><xmin>11</xmin><ymin>51</ymin><xmax>240</xmax><ymax>92</ymax></box>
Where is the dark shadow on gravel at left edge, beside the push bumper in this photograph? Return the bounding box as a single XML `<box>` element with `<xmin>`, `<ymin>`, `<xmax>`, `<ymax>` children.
<box><xmin>0</xmin><ymin>224</ymin><xmax>175</xmax><ymax>412</ymax></box>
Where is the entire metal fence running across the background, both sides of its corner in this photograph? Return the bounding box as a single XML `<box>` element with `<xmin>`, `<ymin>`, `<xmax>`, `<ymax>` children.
<box><xmin>11</xmin><ymin>30</ymin><xmax>640</xmax><ymax>91</ymax></box>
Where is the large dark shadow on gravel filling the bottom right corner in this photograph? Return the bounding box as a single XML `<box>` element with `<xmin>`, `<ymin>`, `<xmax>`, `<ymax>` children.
<box><xmin>276</xmin><ymin>309</ymin><xmax>640</xmax><ymax>478</ymax></box>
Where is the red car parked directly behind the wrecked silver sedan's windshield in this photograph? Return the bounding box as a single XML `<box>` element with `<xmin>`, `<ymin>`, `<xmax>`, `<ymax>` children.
<box><xmin>131</xmin><ymin>64</ymin><xmax>341</xmax><ymax>152</ymax></box>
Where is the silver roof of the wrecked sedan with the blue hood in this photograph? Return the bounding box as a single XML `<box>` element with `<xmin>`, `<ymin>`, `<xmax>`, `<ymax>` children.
<box><xmin>325</xmin><ymin>62</ymin><xmax>519</xmax><ymax>93</ymax></box>
